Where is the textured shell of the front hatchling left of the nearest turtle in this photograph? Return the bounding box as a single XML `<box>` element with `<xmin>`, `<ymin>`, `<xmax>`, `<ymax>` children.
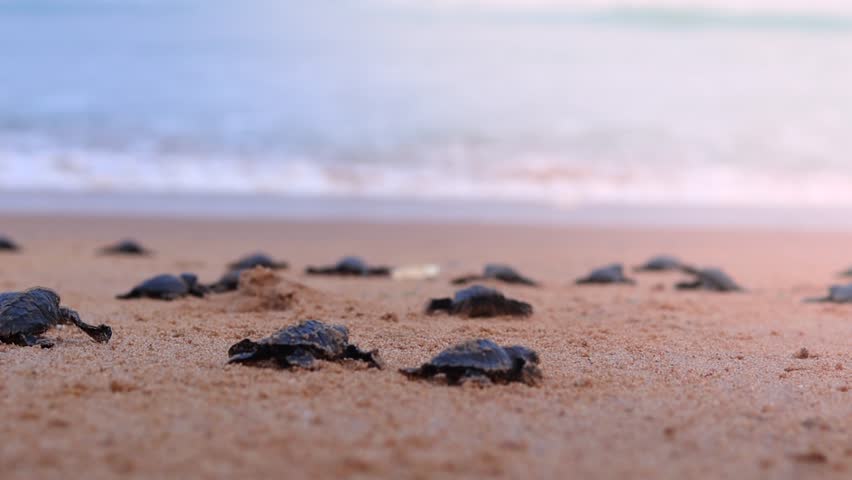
<box><xmin>257</xmin><ymin>320</ymin><xmax>349</xmax><ymax>358</ymax></box>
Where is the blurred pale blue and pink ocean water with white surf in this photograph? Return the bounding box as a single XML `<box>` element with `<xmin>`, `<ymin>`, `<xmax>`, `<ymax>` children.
<box><xmin>5</xmin><ymin>0</ymin><xmax>852</xmax><ymax>208</ymax></box>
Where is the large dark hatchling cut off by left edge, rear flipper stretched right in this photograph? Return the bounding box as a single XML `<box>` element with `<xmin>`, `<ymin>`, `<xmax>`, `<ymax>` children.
<box><xmin>0</xmin><ymin>287</ymin><xmax>112</xmax><ymax>348</ymax></box>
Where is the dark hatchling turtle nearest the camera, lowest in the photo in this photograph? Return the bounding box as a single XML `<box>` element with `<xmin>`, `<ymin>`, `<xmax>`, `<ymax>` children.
<box><xmin>400</xmin><ymin>339</ymin><xmax>541</xmax><ymax>385</ymax></box>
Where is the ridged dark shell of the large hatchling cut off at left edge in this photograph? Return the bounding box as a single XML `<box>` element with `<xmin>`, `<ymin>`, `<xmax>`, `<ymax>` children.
<box><xmin>0</xmin><ymin>288</ymin><xmax>60</xmax><ymax>337</ymax></box>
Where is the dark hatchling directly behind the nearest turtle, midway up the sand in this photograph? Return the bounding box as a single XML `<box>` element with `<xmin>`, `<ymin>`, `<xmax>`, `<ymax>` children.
<box><xmin>426</xmin><ymin>285</ymin><xmax>533</xmax><ymax>318</ymax></box>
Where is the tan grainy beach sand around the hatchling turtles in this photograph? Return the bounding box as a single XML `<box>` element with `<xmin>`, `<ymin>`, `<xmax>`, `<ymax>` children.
<box><xmin>0</xmin><ymin>217</ymin><xmax>852</xmax><ymax>479</ymax></box>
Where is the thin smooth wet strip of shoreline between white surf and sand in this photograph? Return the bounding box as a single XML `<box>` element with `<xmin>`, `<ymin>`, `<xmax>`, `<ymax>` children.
<box><xmin>5</xmin><ymin>191</ymin><xmax>852</xmax><ymax>232</ymax></box>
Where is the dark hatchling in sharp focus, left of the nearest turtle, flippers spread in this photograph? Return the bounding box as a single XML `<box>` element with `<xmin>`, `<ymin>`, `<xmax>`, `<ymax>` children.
<box><xmin>228</xmin><ymin>320</ymin><xmax>384</xmax><ymax>369</ymax></box>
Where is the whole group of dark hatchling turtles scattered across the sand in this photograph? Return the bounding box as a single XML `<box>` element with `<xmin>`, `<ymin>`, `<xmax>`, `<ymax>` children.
<box><xmin>5</xmin><ymin>237</ymin><xmax>852</xmax><ymax>385</ymax></box>
